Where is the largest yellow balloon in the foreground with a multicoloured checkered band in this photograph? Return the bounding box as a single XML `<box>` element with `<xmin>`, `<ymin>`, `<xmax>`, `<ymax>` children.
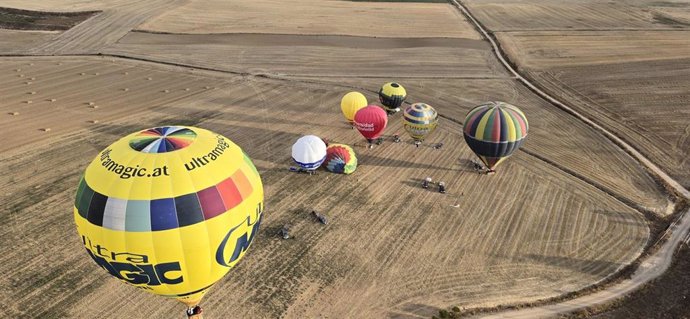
<box><xmin>74</xmin><ymin>126</ymin><xmax>264</xmax><ymax>318</ymax></box>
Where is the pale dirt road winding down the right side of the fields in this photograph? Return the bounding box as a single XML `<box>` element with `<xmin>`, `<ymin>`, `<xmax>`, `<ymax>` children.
<box><xmin>453</xmin><ymin>0</ymin><xmax>690</xmax><ymax>318</ymax></box>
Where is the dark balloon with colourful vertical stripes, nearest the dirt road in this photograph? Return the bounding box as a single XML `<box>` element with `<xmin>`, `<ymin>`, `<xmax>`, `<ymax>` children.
<box><xmin>463</xmin><ymin>102</ymin><xmax>529</xmax><ymax>172</ymax></box>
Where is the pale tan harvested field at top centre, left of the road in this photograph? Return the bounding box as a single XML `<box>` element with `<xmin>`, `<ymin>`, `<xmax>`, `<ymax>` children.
<box><xmin>139</xmin><ymin>0</ymin><xmax>479</xmax><ymax>39</ymax></box>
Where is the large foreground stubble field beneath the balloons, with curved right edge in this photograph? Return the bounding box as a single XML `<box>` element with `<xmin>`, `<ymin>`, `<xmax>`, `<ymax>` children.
<box><xmin>0</xmin><ymin>58</ymin><xmax>653</xmax><ymax>318</ymax></box>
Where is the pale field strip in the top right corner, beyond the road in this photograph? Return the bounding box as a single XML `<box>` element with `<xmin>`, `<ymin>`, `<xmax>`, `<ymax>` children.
<box><xmin>465</xmin><ymin>0</ymin><xmax>688</xmax><ymax>32</ymax></box>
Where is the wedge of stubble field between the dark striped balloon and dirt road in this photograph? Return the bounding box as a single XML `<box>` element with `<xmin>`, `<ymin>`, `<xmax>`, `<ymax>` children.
<box><xmin>288</xmin><ymin>79</ymin><xmax>670</xmax><ymax>215</ymax></box>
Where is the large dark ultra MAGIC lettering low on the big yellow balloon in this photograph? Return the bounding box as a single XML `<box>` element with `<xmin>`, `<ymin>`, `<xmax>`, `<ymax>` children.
<box><xmin>81</xmin><ymin>235</ymin><xmax>184</xmax><ymax>289</ymax></box>
